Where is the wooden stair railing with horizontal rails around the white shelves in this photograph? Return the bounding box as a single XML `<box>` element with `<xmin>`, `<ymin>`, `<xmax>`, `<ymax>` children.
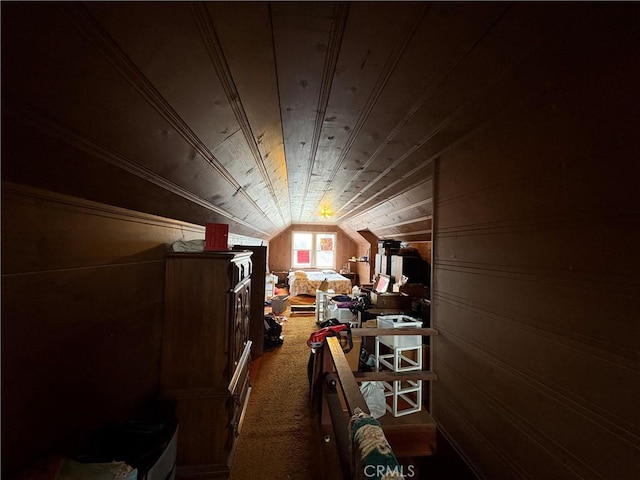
<box><xmin>309</xmin><ymin>328</ymin><xmax>437</xmax><ymax>480</ymax></box>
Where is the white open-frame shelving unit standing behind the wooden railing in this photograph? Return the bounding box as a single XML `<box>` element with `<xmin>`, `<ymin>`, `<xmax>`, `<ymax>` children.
<box><xmin>375</xmin><ymin>315</ymin><xmax>422</xmax><ymax>417</ymax></box>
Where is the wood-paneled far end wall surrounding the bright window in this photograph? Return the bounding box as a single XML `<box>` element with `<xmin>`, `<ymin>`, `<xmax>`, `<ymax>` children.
<box><xmin>269</xmin><ymin>224</ymin><xmax>358</xmax><ymax>272</ymax></box>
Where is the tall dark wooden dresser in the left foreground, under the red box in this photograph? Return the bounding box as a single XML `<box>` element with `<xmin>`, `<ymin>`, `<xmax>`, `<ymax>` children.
<box><xmin>161</xmin><ymin>251</ymin><xmax>252</xmax><ymax>479</ymax></box>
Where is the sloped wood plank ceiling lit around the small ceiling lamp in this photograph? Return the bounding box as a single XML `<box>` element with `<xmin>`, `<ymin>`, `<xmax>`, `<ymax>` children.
<box><xmin>2</xmin><ymin>2</ymin><xmax>604</xmax><ymax>242</ymax></box>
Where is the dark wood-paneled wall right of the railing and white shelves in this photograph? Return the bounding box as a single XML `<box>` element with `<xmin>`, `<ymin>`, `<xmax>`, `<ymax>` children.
<box><xmin>431</xmin><ymin>10</ymin><xmax>640</xmax><ymax>480</ymax></box>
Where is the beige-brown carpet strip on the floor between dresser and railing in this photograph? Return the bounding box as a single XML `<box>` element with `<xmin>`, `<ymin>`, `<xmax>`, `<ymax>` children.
<box><xmin>230</xmin><ymin>310</ymin><xmax>338</xmax><ymax>480</ymax></box>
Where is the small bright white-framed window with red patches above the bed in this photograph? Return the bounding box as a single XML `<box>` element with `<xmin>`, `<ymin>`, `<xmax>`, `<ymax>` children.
<box><xmin>291</xmin><ymin>232</ymin><xmax>336</xmax><ymax>269</ymax></box>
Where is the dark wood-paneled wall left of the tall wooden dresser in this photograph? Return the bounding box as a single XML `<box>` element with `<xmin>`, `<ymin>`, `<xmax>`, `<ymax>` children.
<box><xmin>2</xmin><ymin>182</ymin><xmax>204</xmax><ymax>478</ymax></box>
